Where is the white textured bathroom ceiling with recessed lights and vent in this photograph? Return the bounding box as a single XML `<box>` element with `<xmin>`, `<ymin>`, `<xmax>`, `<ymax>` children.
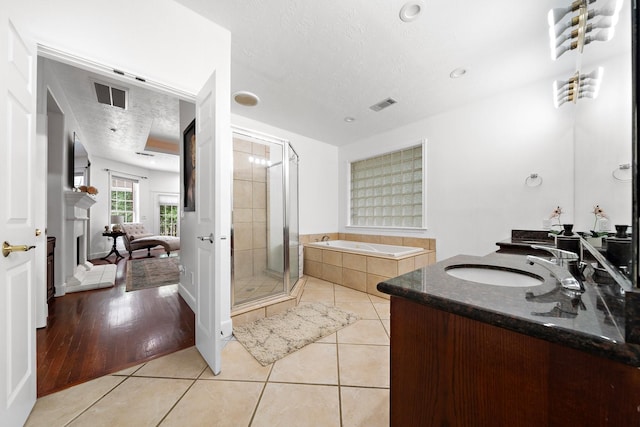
<box><xmin>176</xmin><ymin>0</ymin><xmax>630</xmax><ymax>145</ymax></box>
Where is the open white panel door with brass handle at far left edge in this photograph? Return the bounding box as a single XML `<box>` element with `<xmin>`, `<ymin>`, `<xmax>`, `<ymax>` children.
<box><xmin>0</xmin><ymin>14</ymin><xmax>38</xmax><ymax>426</ymax></box>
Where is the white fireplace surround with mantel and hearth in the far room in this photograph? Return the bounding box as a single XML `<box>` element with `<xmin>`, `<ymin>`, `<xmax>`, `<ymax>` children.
<box><xmin>62</xmin><ymin>191</ymin><xmax>116</xmax><ymax>296</ymax></box>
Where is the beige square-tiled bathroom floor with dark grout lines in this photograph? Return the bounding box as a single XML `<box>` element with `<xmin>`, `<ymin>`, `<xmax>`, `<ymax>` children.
<box><xmin>26</xmin><ymin>278</ymin><xmax>390</xmax><ymax>427</ymax></box>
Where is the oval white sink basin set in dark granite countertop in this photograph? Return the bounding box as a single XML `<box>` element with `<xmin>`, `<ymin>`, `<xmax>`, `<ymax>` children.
<box><xmin>446</xmin><ymin>265</ymin><xmax>544</xmax><ymax>288</ymax></box>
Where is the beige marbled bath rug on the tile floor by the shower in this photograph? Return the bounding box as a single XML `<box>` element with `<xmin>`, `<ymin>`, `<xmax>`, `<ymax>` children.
<box><xmin>233</xmin><ymin>303</ymin><xmax>358</xmax><ymax>366</ymax></box>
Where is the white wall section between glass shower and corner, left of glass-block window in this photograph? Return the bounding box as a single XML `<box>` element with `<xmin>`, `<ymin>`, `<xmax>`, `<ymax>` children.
<box><xmin>231</xmin><ymin>114</ymin><xmax>338</xmax><ymax>234</ymax></box>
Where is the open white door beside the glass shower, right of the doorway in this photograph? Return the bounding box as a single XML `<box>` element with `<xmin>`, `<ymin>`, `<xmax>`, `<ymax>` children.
<box><xmin>195</xmin><ymin>72</ymin><xmax>231</xmax><ymax>375</ymax></box>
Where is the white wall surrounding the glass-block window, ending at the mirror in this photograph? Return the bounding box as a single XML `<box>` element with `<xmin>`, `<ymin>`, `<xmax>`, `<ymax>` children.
<box><xmin>338</xmin><ymin>76</ymin><xmax>574</xmax><ymax>260</ymax></box>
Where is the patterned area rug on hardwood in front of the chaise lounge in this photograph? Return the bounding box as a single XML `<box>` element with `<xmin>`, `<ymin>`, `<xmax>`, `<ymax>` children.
<box><xmin>126</xmin><ymin>257</ymin><xmax>180</xmax><ymax>292</ymax></box>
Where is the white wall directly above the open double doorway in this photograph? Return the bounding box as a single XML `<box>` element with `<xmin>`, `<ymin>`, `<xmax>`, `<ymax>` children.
<box><xmin>15</xmin><ymin>0</ymin><xmax>229</xmax><ymax>95</ymax></box>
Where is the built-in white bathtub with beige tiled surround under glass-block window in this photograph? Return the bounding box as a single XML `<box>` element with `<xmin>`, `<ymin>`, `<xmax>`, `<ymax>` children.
<box><xmin>304</xmin><ymin>236</ymin><xmax>436</xmax><ymax>299</ymax></box>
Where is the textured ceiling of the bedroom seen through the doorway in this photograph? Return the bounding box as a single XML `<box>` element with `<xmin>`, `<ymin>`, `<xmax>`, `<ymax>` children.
<box><xmin>44</xmin><ymin>59</ymin><xmax>182</xmax><ymax>172</ymax></box>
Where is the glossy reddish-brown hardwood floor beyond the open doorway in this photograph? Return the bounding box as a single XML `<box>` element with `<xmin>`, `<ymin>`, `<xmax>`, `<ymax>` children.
<box><xmin>36</xmin><ymin>250</ymin><xmax>195</xmax><ymax>397</ymax></box>
